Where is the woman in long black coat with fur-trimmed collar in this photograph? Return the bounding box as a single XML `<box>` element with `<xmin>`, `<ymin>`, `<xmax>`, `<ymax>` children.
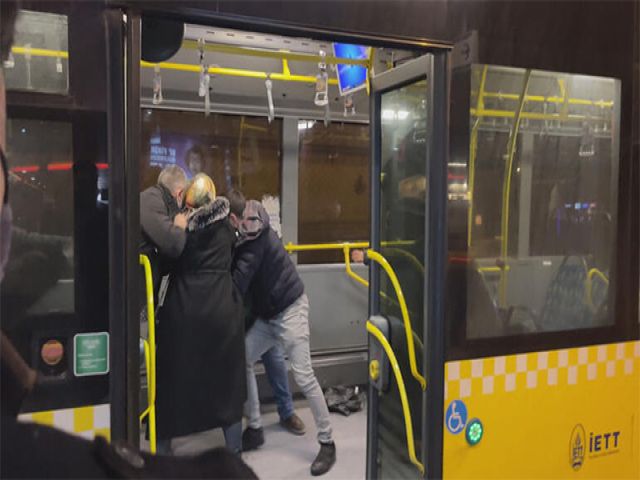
<box><xmin>156</xmin><ymin>174</ymin><xmax>246</xmax><ymax>452</ymax></box>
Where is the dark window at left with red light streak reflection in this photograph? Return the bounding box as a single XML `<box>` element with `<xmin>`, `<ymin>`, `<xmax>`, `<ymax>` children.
<box><xmin>0</xmin><ymin>120</ymin><xmax>74</xmax><ymax>328</ymax></box>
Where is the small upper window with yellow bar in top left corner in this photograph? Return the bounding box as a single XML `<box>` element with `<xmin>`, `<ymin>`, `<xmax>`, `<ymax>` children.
<box><xmin>4</xmin><ymin>10</ymin><xmax>69</xmax><ymax>93</ymax></box>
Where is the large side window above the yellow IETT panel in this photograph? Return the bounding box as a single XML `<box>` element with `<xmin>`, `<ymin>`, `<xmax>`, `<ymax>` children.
<box><xmin>466</xmin><ymin>65</ymin><xmax>620</xmax><ymax>338</ymax></box>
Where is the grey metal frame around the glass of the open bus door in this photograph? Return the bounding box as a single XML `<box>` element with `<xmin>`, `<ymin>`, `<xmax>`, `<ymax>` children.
<box><xmin>367</xmin><ymin>51</ymin><xmax>449</xmax><ymax>478</ymax></box>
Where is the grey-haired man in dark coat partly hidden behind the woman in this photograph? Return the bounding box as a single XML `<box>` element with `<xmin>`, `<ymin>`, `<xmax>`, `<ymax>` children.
<box><xmin>140</xmin><ymin>165</ymin><xmax>187</xmax><ymax>304</ymax></box>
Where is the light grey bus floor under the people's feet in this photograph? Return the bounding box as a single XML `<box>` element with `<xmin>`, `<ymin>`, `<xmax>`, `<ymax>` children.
<box><xmin>143</xmin><ymin>400</ymin><xmax>367</xmax><ymax>480</ymax></box>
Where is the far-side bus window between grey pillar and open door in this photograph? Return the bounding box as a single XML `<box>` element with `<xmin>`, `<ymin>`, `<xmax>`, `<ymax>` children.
<box><xmin>298</xmin><ymin>121</ymin><xmax>370</xmax><ymax>263</ymax></box>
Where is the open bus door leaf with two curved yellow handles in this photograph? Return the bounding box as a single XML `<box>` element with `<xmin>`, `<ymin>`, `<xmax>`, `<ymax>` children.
<box><xmin>367</xmin><ymin>50</ymin><xmax>447</xmax><ymax>478</ymax></box>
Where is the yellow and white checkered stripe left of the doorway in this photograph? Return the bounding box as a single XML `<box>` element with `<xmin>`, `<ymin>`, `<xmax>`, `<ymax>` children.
<box><xmin>18</xmin><ymin>404</ymin><xmax>111</xmax><ymax>440</ymax></box>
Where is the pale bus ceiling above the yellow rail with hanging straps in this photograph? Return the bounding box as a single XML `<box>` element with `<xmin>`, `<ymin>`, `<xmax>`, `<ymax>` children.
<box><xmin>141</xmin><ymin>25</ymin><xmax>413</xmax><ymax>121</ymax></box>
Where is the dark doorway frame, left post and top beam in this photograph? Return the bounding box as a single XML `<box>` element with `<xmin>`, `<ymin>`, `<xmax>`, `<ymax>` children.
<box><xmin>105</xmin><ymin>0</ymin><xmax>452</xmax><ymax>454</ymax></box>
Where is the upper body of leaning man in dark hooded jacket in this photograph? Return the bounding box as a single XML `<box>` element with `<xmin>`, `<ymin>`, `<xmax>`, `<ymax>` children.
<box><xmin>233</xmin><ymin>200</ymin><xmax>304</xmax><ymax>320</ymax></box>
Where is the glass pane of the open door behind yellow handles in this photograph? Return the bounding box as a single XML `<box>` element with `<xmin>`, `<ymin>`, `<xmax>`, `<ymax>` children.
<box><xmin>378</xmin><ymin>80</ymin><xmax>427</xmax><ymax>478</ymax></box>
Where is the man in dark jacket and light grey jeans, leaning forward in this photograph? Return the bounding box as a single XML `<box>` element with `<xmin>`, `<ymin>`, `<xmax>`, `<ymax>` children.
<box><xmin>233</xmin><ymin>200</ymin><xmax>336</xmax><ymax>475</ymax></box>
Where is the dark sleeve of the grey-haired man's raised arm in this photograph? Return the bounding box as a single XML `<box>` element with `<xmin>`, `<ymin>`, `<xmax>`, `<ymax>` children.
<box><xmin>140</xmin><ymin>189</ymin><xmax>187</xmax><ymax>258</ymax></box>
